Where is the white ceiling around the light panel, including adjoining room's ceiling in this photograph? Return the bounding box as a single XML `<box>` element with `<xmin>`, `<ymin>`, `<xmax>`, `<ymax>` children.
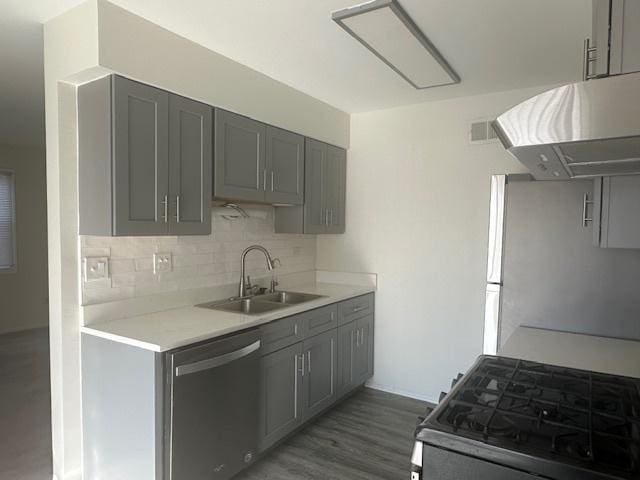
<box><xmin>0</xmin><ymin>0</ymin><xmax>591</xmax><ymax>144</ymax></box>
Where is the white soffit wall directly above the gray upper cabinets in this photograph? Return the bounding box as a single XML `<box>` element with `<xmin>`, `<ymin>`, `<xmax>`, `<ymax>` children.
<box><xmin>98</xmin><ymin>0</ymin><xmax>349</xmax><ymax>147</ymax></box>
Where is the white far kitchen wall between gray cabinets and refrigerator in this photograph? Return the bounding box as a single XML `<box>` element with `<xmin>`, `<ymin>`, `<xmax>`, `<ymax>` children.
<box><xmin>317</xmin><ymin>89</ymin><xmax>552</xmax><ymax>401</ymax></box>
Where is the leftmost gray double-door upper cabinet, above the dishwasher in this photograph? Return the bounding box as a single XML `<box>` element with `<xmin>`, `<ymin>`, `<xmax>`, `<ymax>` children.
<box><xmin>78</xmin><ymin>75</ymin><xmax>212</xmax><ymax>236</ymax></box>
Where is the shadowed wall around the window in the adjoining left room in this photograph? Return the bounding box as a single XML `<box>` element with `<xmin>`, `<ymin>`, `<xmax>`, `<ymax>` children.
<box><xmin>0</xmin><ymin>145</ymin><xmax>49</xmax><ymax>333</ymax></box>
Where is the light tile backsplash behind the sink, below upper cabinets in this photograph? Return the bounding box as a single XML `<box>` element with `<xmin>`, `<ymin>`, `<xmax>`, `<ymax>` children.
<box><xmin>80</xmin><ymin>207</ymin><xmax>316</xmax><ymax>305</ymax></box>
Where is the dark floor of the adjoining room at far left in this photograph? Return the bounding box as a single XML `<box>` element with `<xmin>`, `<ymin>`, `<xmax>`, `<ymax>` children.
<box><xmin>0</xmin><ymin>328</ymin><xmax>52</xmax><ymax>480</ymax></box>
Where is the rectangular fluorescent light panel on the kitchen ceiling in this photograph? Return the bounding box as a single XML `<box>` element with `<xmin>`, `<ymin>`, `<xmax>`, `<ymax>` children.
<box><xmin>332</xmin><ymin>0</ymin><xmax>460</xmax><ymax>89</ymax></box>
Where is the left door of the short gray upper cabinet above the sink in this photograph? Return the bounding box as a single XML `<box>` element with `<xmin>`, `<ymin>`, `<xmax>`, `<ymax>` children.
<box><xmin>213</xmin><ymin>109</ymin><xmax>267</xmax><ymax>202</ymax></box>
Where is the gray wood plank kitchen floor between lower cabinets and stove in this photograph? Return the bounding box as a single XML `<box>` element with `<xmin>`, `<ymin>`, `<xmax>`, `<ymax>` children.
<box><xmin>234</xmin><ymin>389</ymin><xmax>427</xmax><ymax>480</ymax></box>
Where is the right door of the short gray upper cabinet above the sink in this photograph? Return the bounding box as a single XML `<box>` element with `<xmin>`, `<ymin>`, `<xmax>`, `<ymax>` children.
<box><xmin>265</xmin><ymin>126</ymin><xmax>304</xmax><ymax>205</ymax></box>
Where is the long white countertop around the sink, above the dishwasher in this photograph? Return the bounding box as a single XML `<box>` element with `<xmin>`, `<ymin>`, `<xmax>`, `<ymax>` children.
<box><xmin>80</xmin><ymin>283</ymin><xmax>375</xmax><ymax>352</ymax></box>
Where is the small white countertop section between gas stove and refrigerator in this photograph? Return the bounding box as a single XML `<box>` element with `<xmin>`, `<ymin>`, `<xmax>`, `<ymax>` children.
<box><xmin>499</xmin><ymin>327</ymin><xmax>640</xmax><ymax>378</ymax></box>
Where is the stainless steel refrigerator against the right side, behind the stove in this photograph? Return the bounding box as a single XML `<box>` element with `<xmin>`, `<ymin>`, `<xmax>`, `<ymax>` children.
<box><xmin>484</xmin><ymin>175</ymin><xmax>640</xmax><ymax>354</ymax></box>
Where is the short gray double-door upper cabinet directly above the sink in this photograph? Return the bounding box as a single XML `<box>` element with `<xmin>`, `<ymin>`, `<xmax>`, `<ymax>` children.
<box><xmin>213</xmin><ymin>109</ymin><xmax>304</xmax><ymax>205</ymax></box>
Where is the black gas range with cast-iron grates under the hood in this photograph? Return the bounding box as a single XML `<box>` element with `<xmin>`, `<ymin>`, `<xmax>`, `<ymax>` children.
<box><xmin>411</xmin><ymin>356</ymin><xmax>640</xmax><ymax>480</ymax></box>
